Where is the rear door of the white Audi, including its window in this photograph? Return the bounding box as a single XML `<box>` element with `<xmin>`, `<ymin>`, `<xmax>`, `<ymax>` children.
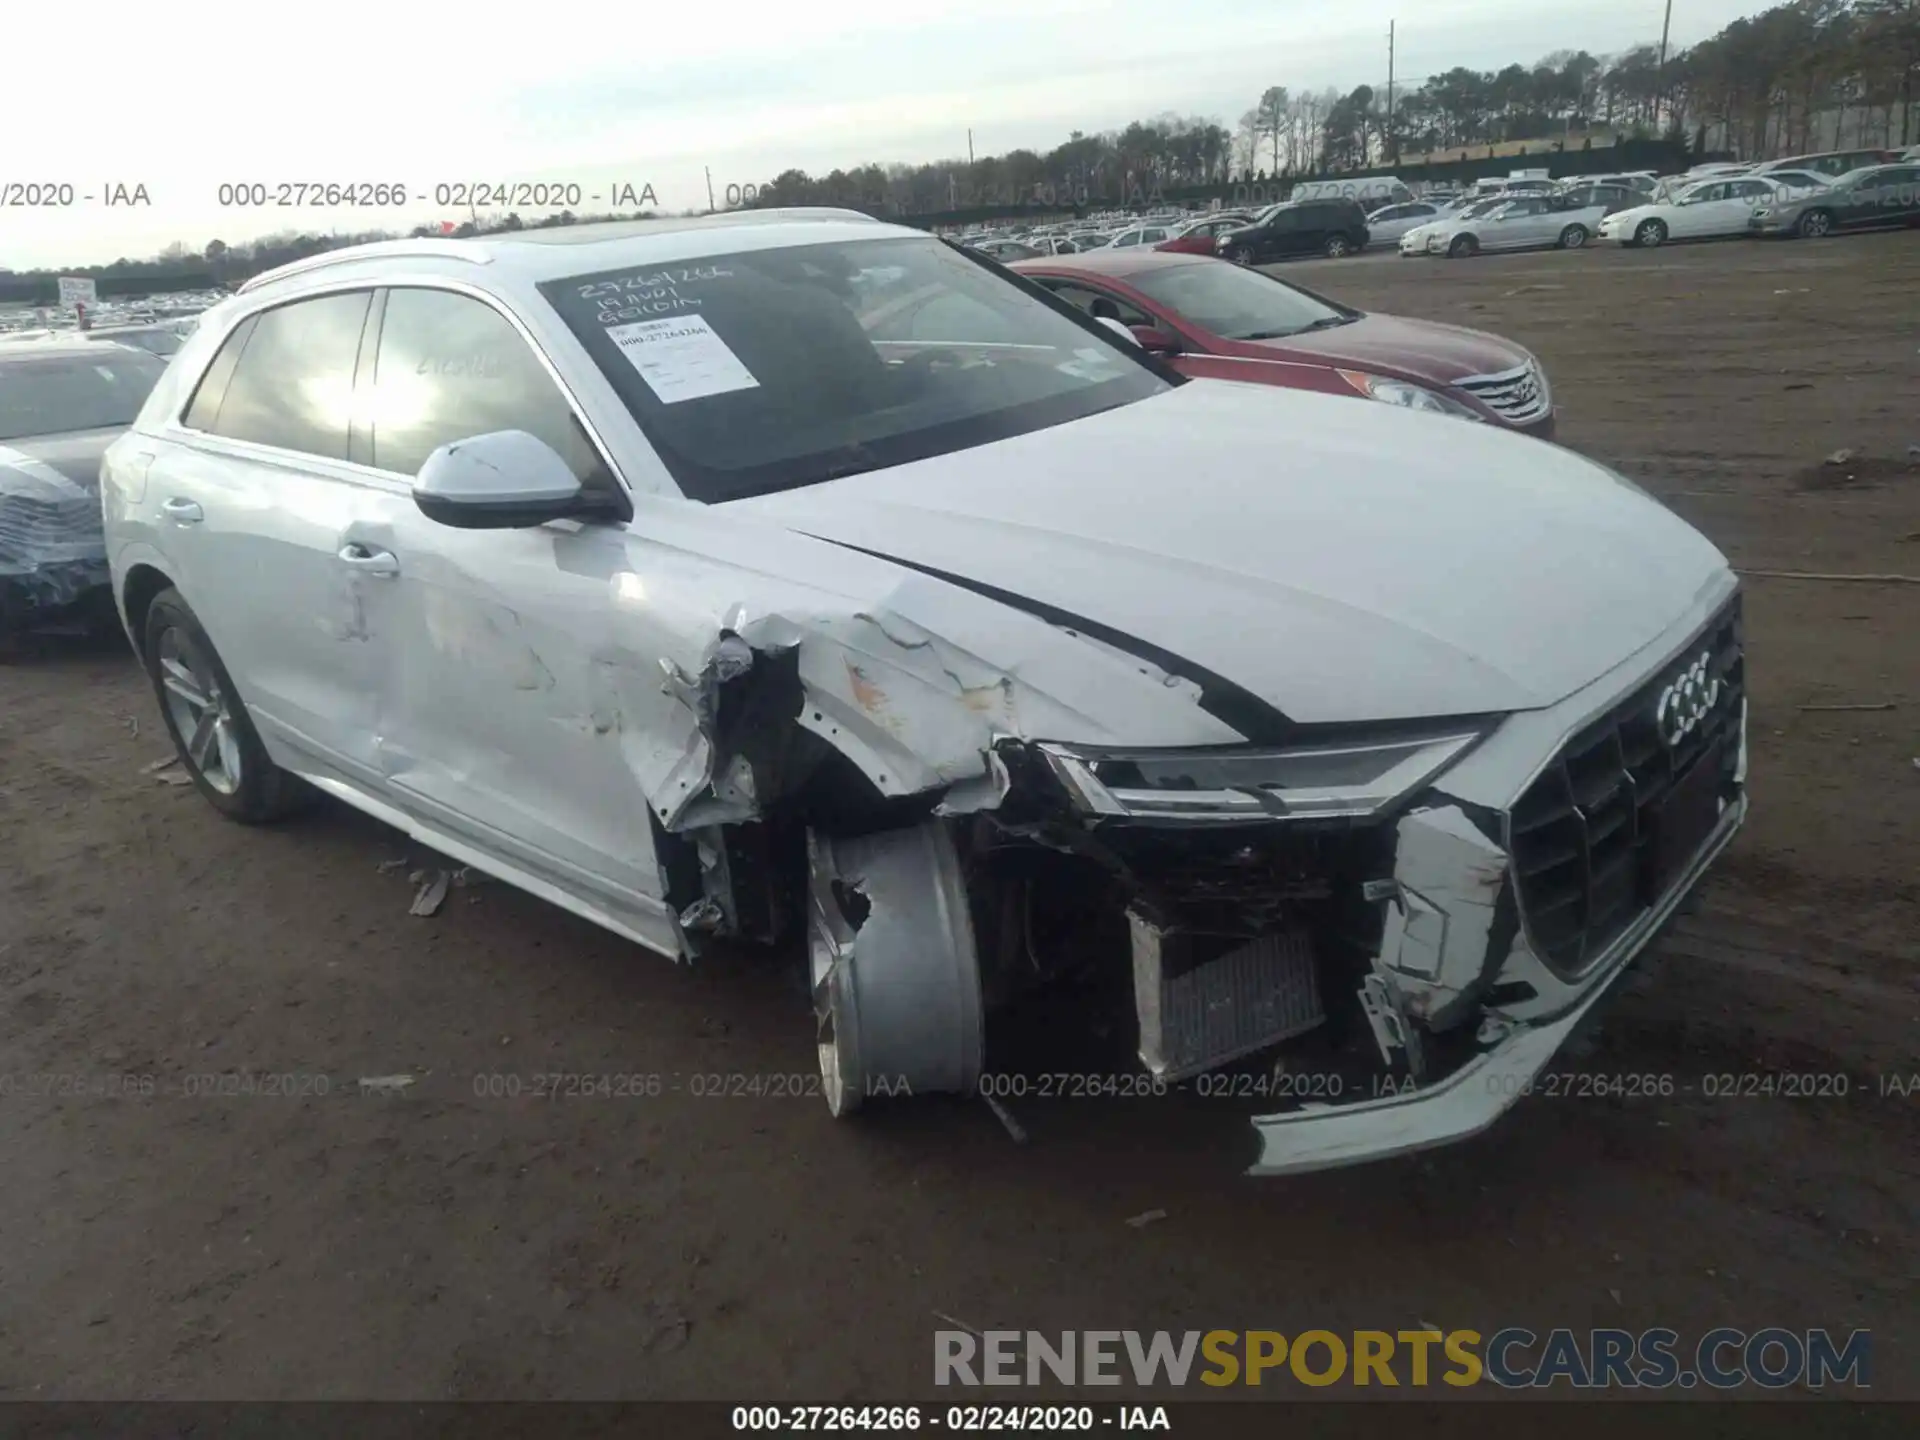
<box><xmin>146</xmin><ymin>288</ymin><xmax>384</xmax><ymax>787</ymax></box>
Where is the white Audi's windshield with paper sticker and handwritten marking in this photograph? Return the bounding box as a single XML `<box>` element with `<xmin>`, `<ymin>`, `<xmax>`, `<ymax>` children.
<box><xmin>540</xmin><ymin>236</ymin><xmax>1171</xmax><ymax>503</ymax></box>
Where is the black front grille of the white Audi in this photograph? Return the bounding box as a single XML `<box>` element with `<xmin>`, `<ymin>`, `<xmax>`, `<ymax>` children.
<box><xmin>1507</xmin><ymin>595</ymin><xmax>1747</xmax><ymax>973</ymax></box>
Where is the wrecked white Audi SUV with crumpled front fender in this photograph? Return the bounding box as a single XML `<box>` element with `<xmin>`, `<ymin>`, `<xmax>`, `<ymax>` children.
<box><xmin>102</xmin><ymin>211</ymin><xmax>1747</xmax><ymax>1173</ymax></box>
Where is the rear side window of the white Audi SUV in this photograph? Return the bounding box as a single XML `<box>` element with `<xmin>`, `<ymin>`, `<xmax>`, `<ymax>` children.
<box><xmin>207</xmin><ymin>290</ymin><xmax>372</xmax><ymax>461</ymax></box>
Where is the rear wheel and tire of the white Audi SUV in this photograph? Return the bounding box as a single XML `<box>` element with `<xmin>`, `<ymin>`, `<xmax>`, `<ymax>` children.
<box><xmin>140</xmin><ymin>589</ymin><xmax>313</xmax><ymax>826</ymax></box>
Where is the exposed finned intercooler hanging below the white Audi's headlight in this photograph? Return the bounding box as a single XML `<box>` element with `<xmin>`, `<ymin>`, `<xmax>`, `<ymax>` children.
<box><xmin>1127</xmin><ymin>910</ymin><xmax>1325</xmax><ymax>1081</ymax></box>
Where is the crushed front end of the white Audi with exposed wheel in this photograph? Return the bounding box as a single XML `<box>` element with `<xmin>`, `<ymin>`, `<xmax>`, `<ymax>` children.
<box><xmin>633</xmin><ymin>564</ymin><xmax>1745</xmax><ymax>1175</ymax></box>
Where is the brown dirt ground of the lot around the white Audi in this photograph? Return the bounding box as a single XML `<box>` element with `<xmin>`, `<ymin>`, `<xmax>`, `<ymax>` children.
<box><xmin>0</xmin><ymin>232</ymin><xmax>1920</xmax><ymax>1400</ymax></box>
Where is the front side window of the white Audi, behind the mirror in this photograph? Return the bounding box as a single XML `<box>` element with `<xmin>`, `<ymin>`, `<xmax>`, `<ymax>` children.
<box><xmin>363</xmin><ymin>290</ymin><xmax>612</xmax><ymax>490</ymax></box>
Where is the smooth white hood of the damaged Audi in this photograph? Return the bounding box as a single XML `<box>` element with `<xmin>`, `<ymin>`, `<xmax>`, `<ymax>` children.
<box><xmin>735</xmin><ymin>380</ymin><xmax>1726</xmax><ymax>722</ymax></box>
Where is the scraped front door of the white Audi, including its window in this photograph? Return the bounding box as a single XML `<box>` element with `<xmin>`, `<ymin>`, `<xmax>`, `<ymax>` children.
<box><xmin>355</xmin><ymin>288</ymin><xmax>674</xmax><ymax>948</ymax></box>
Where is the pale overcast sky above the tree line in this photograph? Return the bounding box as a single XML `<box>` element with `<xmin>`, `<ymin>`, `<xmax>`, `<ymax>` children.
<box><xmin>0</xmin><ymin>0</ymin><xmax>1763</xmax><ymax>269</ymax></box>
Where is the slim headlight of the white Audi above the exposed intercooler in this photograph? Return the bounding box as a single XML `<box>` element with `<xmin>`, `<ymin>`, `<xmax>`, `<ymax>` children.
<box><xmin>1039</xmin><ymin>733</ymin><xmax>1492</xmax><ymax>820</ymax></box>
